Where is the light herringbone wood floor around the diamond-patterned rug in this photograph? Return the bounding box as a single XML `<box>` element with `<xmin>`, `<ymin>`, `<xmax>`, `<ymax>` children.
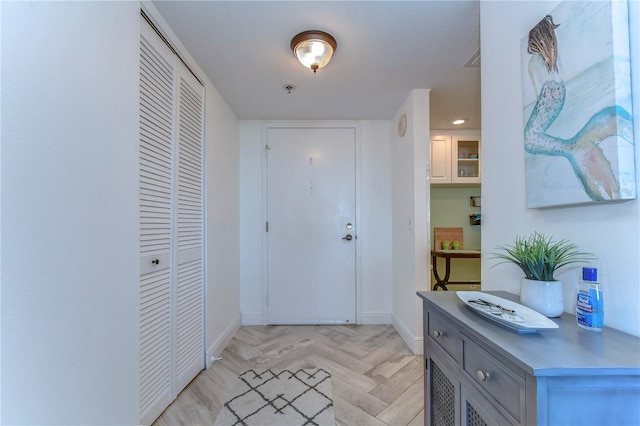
<box><xmin>154</xmin><ymin>325</ymin><xmax>424</xmax><ymax>426</ymax></box>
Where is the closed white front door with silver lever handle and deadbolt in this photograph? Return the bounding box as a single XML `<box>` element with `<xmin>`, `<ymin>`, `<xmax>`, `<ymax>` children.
<box><xmin>267</xmin><ymin>128</ymin><xmax>357</xmax><ymax>324</ymax></box>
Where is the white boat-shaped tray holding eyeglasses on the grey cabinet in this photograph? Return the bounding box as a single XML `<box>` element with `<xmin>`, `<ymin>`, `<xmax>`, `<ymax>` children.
<box><xmin>456</xmin><ymin>291</ymin><xmax>558</xmax><ymax>333</ymax></box>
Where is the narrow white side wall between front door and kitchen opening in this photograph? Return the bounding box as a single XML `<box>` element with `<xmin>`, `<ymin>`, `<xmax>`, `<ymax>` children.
<box><xmin>391</xmin><ymin>89</ymin><xmax>429</xmax><ymax>353</ymax></box>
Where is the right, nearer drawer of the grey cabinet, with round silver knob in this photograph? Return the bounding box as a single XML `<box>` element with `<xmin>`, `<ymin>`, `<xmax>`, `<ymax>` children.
<box><xmin>462</xmin><ymin>336</ymin><xmax>525</xmax><ymax>423</ymax></box>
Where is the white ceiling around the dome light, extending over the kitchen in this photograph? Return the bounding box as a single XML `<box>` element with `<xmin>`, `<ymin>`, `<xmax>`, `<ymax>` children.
<box><xmin>154</xmin><ymin>0</ymin><xmax>480</xmax><ymax>129</ymax></box>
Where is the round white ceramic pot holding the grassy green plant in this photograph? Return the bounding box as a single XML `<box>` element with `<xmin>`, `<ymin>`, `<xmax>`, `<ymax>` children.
<box><xmin>520</xmin><ymin>278</ymin><xmax>564</xmax><ymax>318</ymax></box>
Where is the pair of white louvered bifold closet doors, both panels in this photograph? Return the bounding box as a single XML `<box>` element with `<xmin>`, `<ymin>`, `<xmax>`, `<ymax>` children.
<box><xmin>139</xmin><ymin>13</ymin><xmax>205</xmax><ymax>425</ymax></box>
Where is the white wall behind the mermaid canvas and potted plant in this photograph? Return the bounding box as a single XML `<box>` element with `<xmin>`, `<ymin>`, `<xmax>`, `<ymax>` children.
<box><xmin>480</xmin><ymin>1</ymin><xmax>640</xmax><ymax>336</ymax></box>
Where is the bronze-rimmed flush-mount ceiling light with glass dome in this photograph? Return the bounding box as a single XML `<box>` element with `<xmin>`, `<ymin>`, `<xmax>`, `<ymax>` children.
<box><xmin>291</xmin><ymin>30</ymin><xmax>338</xmax><ymax>74</ymax></box>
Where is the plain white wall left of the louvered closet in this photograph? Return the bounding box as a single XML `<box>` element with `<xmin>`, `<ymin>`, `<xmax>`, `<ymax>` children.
<box><xmin>1</xmin><ymin>2</ymin><xmax>140</xmax><ymax>424</ymax></box>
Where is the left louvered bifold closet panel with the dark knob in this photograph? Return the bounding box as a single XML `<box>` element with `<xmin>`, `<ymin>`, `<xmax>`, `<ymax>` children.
<box><xmin>139</xmin><ymin>19</ymin><xmax>175</xmax><ymax>424</ymax></box>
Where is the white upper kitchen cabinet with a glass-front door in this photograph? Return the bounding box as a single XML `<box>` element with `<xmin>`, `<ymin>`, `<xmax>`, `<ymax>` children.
<box><xmin>430</xmin><ymin>131</ymin><xmax>481</xmax><ymax>184</ymax></box>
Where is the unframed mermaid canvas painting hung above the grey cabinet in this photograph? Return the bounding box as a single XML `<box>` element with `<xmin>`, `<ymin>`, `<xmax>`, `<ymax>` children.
<box><xmin>521</xmin><ymin>0</ymin><xmax>636</xmax><ymax>208</ymax></box>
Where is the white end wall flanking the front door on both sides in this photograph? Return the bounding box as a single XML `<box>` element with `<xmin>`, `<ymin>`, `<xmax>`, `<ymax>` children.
<box><xmin>240</xmin><ymin>121</ymin><xmax>392</xmax><ymax>324</ymax></box>
